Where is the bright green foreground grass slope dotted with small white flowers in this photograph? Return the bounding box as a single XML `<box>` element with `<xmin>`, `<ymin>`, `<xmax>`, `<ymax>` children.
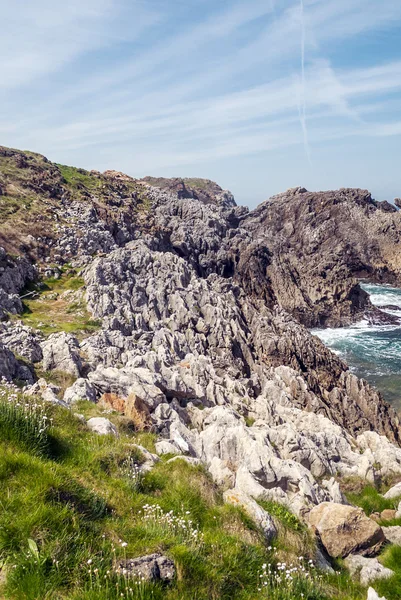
<box><xmin>0</xmin><ymin>386</ymin><xmax>401</xmax><ymax>600</ymax></box>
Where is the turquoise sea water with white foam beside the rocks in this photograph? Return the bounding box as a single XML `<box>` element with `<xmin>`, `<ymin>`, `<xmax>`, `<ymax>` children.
<box><xmin>312</xmin><ymin>284</ymin><xmax>401</xmax><ymax>411</ymax></box>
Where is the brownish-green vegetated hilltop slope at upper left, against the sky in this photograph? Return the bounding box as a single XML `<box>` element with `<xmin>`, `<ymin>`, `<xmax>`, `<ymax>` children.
<box><xmin>0</xmin><ymin>146</ymin><xmax>149</xmax><ymax>262</ymax></box>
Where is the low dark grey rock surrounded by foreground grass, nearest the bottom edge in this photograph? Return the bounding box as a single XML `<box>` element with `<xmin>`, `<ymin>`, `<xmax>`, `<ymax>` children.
<box><xmin>115</xmin><ymin>554</ymin><xmax>175</xmax><ymax>583</ymax></box>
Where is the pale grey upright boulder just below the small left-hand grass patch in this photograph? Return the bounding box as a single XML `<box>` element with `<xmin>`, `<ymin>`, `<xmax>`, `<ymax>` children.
<box><xmin>41</xmin><ymin>331</ymin><xmax>82</xmax><ymax>377</ymax></box>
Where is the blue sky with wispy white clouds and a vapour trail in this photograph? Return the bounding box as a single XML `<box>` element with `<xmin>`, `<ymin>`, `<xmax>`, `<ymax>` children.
<box><xmin>0</xmin><ymin>0</ymin><xmax>401</xmax><ymax>207</ymax></box>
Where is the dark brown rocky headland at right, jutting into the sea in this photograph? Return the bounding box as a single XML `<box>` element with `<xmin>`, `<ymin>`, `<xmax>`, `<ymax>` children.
<box><xmin>236</xmin><ymin>188</ymin><xmax>401</xmax><ymax>326</ymax></box>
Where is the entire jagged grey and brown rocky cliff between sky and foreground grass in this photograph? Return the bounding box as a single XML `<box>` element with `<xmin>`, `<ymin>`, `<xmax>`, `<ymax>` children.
<box><xmin>0</xmin><ymin>149</ymin><xmax>401</xmax><ymax>511</ymax></box>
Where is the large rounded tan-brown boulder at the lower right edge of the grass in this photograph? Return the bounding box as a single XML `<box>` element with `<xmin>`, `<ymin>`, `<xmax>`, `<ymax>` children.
<box><xmin>309</xmin><ymin>502</ymin><xmax>385</xmax><ymax>558</ymax></box>
